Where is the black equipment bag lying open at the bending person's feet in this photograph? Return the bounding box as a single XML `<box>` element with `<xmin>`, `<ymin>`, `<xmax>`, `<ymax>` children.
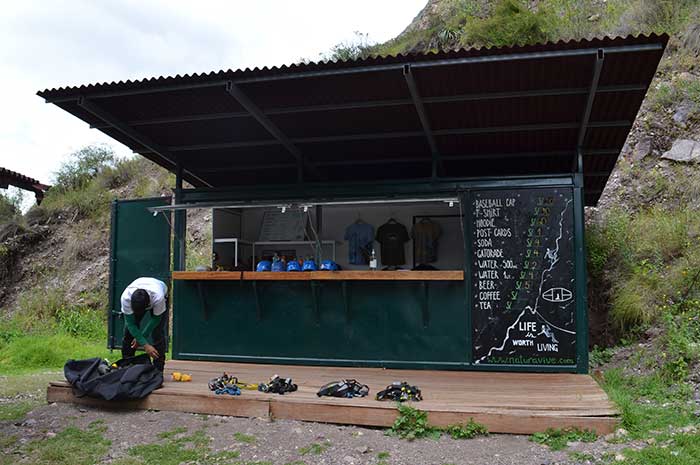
<box><xmin>63</xmin><ymin>354</ymin><xmax>163</xmax><ymax>400</ymax></box>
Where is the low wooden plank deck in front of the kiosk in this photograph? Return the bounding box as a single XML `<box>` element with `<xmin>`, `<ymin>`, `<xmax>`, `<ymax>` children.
<box><xmin>47</xmin><ymin>360</ymin><xmax>618</xmax><ymax>434</ymax></box>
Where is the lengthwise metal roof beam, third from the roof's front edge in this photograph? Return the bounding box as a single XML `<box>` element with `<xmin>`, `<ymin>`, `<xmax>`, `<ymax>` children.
<box><xmin>139</xmin><ymin>121</ymin><xmax>632</xmax><ymax>153</ymax></box>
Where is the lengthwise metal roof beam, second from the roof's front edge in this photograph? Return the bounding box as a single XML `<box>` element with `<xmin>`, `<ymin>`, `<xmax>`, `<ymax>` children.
<box><xmin>91</xmin><ymin>84</ymin><xmax>646</xmax><ymax>129</ymax></box>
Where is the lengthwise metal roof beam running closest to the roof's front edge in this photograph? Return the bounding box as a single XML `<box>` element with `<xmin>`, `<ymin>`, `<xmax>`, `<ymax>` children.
<box><xmin>39</xmin><ymin>43</ymin><xmax>664</xmax><ymax>103</ymax></box>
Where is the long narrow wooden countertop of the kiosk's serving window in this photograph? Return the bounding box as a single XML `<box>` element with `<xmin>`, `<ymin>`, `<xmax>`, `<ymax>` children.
<box><xmin>173</xmin><ymin>270</ymin><xmax>464</xmax><ymax>281</ymax></box>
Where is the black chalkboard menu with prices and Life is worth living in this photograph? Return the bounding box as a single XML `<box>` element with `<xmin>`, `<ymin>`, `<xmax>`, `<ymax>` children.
<box><xmin>471</xmin><ymin>189</ymin><xmax>576</xmax><ymax>365</ymax></box>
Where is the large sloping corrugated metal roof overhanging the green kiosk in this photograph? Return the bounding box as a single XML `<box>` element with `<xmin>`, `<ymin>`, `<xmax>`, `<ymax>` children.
<box><xmin>38</xmin><ymin>34</ymin><xmax>668</xmax><ymax>204</ymax></box>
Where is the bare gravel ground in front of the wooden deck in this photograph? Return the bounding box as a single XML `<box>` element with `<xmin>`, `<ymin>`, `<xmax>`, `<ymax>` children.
<box><xmin>0</xmin><ymin>404</ymin><xmax>629</xmax><ymax>465</ymax></box>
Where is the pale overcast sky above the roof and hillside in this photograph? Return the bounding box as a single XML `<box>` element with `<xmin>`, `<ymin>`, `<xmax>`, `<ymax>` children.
<box><xmin>0</xmin><ymin>0</ymin><xmax>426</xmax><ymax>190</ymax></box>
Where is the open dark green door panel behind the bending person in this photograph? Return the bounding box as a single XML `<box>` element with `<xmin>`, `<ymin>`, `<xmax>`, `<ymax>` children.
<box><xmin>107</xmin><ymin>197</ymin><xmax>170</xmax><ymax>349</ymax></box>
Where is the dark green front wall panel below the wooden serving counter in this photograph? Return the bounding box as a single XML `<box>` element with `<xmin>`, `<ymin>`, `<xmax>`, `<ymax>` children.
<box><xmin>173</xmin><ymin>281</ymin><xmax>467</xmax><ymax>366</ymax></box>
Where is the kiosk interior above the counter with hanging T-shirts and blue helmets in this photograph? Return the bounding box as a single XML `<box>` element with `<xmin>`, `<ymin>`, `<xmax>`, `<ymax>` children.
<box><xmin>211</xmin><ymin>199</ymin><xmax>464</xmax><ymax>271</ymax></box>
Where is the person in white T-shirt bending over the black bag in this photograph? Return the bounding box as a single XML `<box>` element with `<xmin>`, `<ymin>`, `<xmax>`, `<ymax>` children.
<box><xmin>121</xmin><ymin>277</ymin><xmax>168</xmax><ymax>371</ymax></box>
